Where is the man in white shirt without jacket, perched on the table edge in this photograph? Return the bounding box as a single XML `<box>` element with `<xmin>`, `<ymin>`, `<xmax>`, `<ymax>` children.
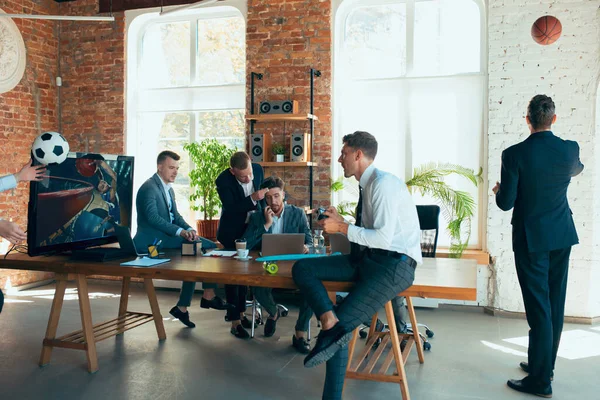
<box><xmin>292</xmin><ymin>131</ymin><xmax>422</xmax><ymax>399</ymax></box>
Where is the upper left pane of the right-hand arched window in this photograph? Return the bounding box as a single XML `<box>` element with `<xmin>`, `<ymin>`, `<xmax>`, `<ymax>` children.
<box><xmin>340</xmin><ymin>4</ymin><xmax>406</xmax><ymax>78</ymax></box>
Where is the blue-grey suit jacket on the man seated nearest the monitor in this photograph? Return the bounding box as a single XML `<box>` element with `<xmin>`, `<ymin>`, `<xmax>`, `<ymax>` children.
<box><xmin>133</xmin><ymin>174</ymin><xmax>216</xmax><ymax>248</ymax></box>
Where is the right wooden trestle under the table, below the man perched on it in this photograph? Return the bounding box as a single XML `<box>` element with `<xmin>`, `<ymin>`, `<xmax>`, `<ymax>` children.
<box><xmin>346</xmin><ymin>297</ymin><xmax>425</xmax><ymax>400</ymax></box>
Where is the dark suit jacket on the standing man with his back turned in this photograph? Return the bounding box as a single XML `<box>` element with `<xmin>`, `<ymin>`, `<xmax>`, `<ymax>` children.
<box><xmin>496</xmin><ymin>131</ymin><xmax>583</xmax><ymax>253</ymax></box>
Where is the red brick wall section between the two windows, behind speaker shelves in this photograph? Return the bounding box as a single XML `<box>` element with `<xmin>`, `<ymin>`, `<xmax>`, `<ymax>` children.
<box><xmin>246</xmin><ymin>0</ymin><xmax>331</xmax><ymax>211</ymax></box>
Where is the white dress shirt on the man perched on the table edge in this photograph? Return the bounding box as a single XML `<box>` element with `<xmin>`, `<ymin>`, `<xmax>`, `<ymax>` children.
<box><xmin>348</xmin><ymin>164</ymin><xmax>423</xmax><ymax>264</ymax></box>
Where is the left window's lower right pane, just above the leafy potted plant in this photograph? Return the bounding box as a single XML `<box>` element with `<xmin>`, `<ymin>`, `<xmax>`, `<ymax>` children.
<box><xmin>196</xmin><ymin>110</ymin><xmax>246</xmax><ymax>150</ymax></box>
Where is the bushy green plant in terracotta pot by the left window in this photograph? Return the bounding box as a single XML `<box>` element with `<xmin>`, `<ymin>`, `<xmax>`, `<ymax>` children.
<box><xmin>183</xmin><ymin>139</ymin><xmax>237</xmax><ymax>240</ymax></box>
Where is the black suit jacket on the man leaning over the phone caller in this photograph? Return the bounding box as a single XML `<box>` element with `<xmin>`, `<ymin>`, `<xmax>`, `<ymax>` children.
<box><xmin>215</xmin><ymin>163</ymin><xmax>263</xmax><ymax>249</ymax></box>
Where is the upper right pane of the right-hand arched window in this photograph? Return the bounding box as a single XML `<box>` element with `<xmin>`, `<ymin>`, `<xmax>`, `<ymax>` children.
<box><xmin>413</xmin><ymin>0</ymin><xmax>481</xmax><ymax>76</ymax></box>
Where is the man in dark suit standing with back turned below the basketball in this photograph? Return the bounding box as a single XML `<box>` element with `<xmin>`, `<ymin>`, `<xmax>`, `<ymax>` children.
<box><xmin>492</xmin><ymin>95</ymin><xmax>583</xmax><ymax>397</ymax></box>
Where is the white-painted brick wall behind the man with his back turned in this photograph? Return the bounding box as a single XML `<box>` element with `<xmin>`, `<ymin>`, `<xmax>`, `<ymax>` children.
<box><xmin>487</xmin><ymin>0</ymin><xmax>600</xmax><ymax>317</ymax></box>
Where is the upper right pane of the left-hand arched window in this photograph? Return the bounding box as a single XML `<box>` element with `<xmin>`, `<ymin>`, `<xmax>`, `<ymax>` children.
<box><xmin>196</xmin><ymin>17</ymin><xmax>246</xmax><ymax>85</ymax></box>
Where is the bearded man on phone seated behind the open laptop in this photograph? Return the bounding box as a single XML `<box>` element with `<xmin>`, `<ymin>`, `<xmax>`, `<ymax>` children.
<box><xmin>244</xmin><ymin>177</ymin><xmax>313</xmax><ymax>354</ymax></box>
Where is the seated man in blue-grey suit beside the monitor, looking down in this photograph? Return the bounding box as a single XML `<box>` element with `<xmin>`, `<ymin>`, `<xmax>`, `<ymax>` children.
<box><xmin>133</xmin><ymin>150</ymin><xmax>227</xmax><ymax>328</ymax></box>
